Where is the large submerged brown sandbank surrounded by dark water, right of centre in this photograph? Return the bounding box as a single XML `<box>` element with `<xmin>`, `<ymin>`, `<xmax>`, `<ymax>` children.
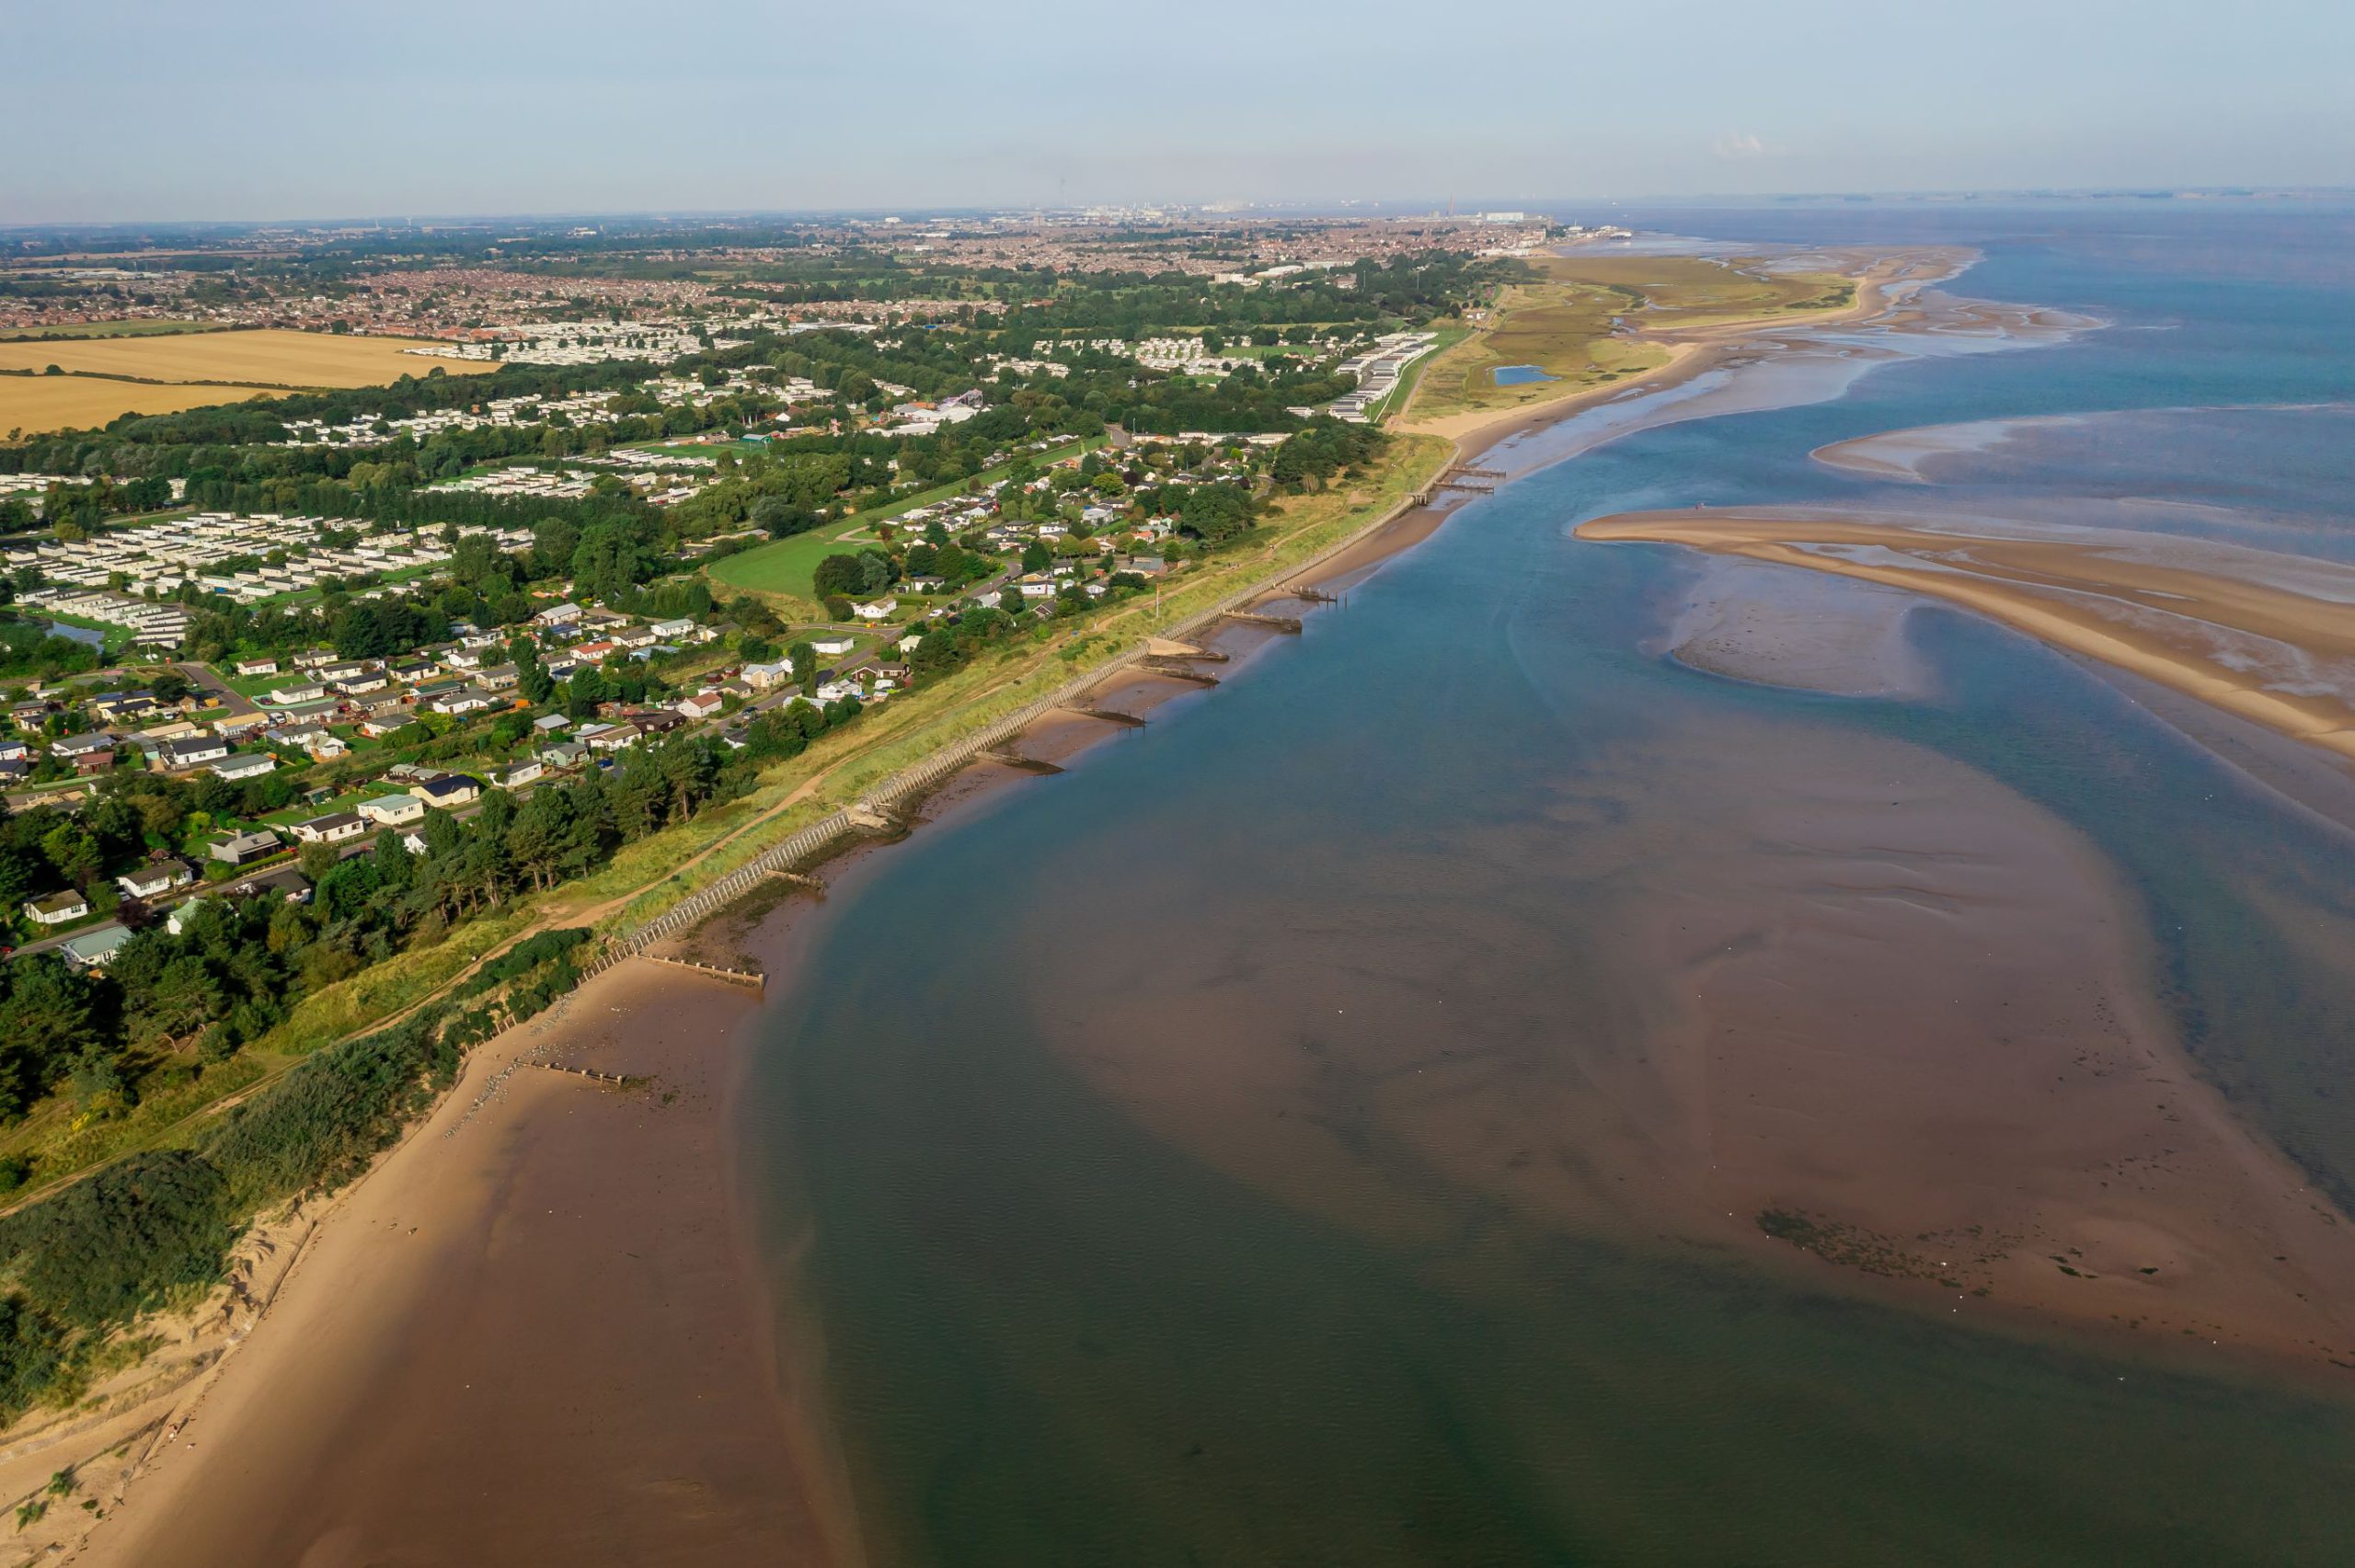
<box><xmin>1048</xmin><ymin>706</ymin><xmax>2355</xmax><ymax>1375</ymax></box>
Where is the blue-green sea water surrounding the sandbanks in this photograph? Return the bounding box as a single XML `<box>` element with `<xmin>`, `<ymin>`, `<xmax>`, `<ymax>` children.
<box><xmin>741</xmin><ymin>205</ymin><xmax>2355</xmax><ymax>1565</ymax></box>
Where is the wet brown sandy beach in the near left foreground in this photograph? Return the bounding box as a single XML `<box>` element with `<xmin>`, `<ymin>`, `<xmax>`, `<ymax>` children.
<box><xmin>73</xmin><ymin>963</ymin><xmax>857</xmax><ymax>1568</ymax></box>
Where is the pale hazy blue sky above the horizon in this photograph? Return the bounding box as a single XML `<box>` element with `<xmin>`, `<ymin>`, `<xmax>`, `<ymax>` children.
<box><xmin>0</xmin><ymin>0</ymin><xmax>2355</xmax><ymax>226</ymax></box>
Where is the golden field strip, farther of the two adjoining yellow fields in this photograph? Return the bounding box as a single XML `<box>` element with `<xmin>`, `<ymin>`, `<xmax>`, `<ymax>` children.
<box><xmin>0</xmin><ymin>327</ymin><xmax>495</xmax><ymax>388</ymax></box>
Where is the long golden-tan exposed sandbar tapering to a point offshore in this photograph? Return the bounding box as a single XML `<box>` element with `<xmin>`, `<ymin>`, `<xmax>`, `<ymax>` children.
<box><xmin>1578</xmin><ymin>509</ymin><xmax>2355</xmax><ymax>758</ymax></box>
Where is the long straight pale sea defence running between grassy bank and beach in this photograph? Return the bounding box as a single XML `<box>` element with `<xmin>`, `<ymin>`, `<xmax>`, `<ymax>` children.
<box><xmin>580</xmin><ymin>471</ymin><xmax>1430</xmax><ymax>979</ymax></box>
